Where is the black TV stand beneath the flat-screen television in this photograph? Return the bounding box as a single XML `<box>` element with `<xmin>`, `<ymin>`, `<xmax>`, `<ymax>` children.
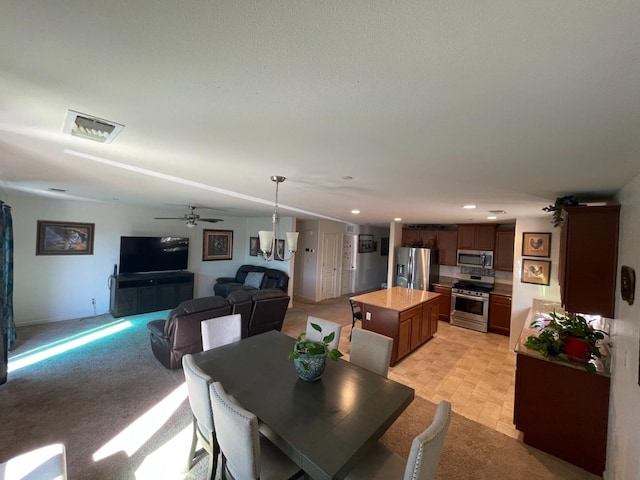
<box><xmin>109</xmin><ymin>271</ymin><xmax>193</xmax><ymax>317</ymax></box>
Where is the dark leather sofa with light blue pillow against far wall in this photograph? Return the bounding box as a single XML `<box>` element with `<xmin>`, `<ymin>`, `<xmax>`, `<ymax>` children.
<box><xmin>213</xmin><ymin>265</ymin><xmax>289</xmax><ymax>297</ymax></box>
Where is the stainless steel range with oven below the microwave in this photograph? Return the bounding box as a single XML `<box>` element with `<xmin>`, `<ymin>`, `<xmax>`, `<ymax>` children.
<box><xmin>451</xmin><ymin>267</ymin><xmax>495</xmax><ymax>332</ymax></box>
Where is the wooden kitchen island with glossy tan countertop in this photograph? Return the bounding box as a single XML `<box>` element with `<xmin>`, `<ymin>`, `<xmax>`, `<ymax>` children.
<box><xmin>351</xmin><ymin>287</ymin><xmax>440</xmax><ymax>366</ymax></box>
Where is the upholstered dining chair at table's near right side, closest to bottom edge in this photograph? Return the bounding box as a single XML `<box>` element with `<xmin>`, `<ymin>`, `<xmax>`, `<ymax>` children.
<box><xmin>346</xmin><ymin>400</ymin><xmax>451</xmax><ymax>480</ymax></box>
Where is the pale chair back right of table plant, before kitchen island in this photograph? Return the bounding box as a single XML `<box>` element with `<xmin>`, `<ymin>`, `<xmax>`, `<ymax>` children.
<box><xmin>349</xmin><ymin>328</ymin><xmax>393</xmax><ymax>377</ymax></box>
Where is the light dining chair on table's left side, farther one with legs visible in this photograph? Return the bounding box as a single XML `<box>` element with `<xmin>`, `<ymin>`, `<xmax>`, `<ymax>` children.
<box><xmin>182</xmin><ymin>354</ymin><xmax>220</xmax><ymax>479</ymax></box>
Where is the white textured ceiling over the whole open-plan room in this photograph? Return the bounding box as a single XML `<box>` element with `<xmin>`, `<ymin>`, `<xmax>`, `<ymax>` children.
<box><xmin>0</xmin><ymin>0</ymin><xmax>640</xmax><ymax>225</ymax></box>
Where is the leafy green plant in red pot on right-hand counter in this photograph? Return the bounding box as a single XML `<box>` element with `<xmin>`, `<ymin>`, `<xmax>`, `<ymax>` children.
<box><xmin>524</xmin><ymin>311</ymin><xmax>606</xmax><ymax>373</ymax></box>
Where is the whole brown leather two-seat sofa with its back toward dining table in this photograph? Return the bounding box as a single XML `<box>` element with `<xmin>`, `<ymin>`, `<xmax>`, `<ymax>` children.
<box><xmin>147</xmin><ymin>289</ymin><xmax>289</xmax><ymax>370</ymax></box>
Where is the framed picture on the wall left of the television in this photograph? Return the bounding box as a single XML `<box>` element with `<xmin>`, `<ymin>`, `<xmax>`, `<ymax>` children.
<box><xmin>36</xmin><ymin>220</ymin><xmax>95</xmax><ymax>255</ymax></box>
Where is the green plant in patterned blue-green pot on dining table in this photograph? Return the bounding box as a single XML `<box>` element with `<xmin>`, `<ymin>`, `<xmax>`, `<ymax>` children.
<box><xmin>289</xmin><ymin>323</ymin><xmax>342</xmax><ymax>382</ymax></box>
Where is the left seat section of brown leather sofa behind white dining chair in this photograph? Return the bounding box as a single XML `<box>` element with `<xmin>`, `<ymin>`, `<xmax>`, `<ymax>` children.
<box><xmin>147</xmin><ymin>297</ymin><xmax>231</xmax><ymax>369</ymax></box>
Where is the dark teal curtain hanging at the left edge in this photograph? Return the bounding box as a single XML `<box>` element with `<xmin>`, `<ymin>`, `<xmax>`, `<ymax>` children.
<box><xmin>0</xmin><ymin>202</ymin><xmax>16</xmax><ymax>383</ymax></box>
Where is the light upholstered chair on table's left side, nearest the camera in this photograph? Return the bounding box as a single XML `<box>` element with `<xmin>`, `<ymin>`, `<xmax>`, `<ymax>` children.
<box><xmin>209</xmin><ymin>382</ymin><xmax>303</xmax><ymax>480</ymax></box>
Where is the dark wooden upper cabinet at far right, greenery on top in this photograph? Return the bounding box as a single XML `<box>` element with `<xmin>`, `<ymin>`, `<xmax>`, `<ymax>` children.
<box><xmin>558</xmin><ymin>205</ymin><xmax>620</xmax><ymax>318</ymax></box>
